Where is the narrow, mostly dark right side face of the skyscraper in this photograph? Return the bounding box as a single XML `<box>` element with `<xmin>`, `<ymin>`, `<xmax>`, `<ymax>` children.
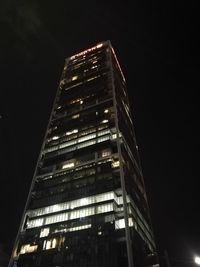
<box><xmin>109</xmin><ymin>45</ymin><xmax>158</xmax><ymax>266</ymax></box>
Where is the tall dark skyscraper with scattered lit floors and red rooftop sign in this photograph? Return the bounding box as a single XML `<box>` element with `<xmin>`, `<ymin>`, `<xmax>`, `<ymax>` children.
<box><xmin>9</xmin><ymin>41</ymin><xmax>158</xmax><ymax>267</ymax></box>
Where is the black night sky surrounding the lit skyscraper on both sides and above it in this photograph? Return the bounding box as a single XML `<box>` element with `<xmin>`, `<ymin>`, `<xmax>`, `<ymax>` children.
<box><xmin>0</xmin><ymin>0</ymin><xmax>200</xmax><ymax>266</ymax></box>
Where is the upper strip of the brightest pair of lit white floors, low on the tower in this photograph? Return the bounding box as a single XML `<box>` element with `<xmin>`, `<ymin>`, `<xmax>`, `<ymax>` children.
<box><xmin>27</xmin><ymin>191</ymin><xmax>122</xmax><ymax>218</ymax></box>
